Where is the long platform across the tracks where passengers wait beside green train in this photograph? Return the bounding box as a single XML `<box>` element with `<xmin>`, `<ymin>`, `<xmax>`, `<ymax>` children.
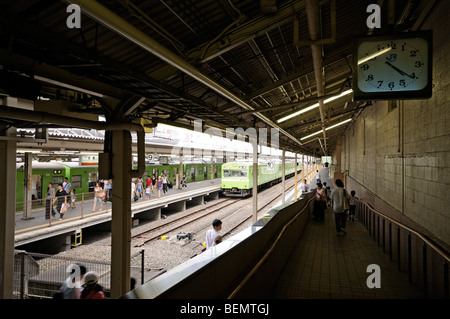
<box><xmin>15</xmin><ymin>178</ymin><xmax>221</xmax><ymax>247</ymax></box>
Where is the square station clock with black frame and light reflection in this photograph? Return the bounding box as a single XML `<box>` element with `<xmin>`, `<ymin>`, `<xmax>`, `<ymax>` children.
<box><xmin>353</xmin><ymin>30</ymin><xmax>432</xmax><ymax>100</ymax></box>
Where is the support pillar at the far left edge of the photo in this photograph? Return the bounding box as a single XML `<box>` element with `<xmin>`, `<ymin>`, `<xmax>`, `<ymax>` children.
<box><xmin>0</xmin><ymin>129</ymin><xmax>17</xmax><ymax>299</ymax></box>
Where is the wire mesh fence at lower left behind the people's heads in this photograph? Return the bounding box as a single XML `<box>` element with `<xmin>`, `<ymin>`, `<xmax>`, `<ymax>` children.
<box><xmin>13</xmin><ymin>250</ymin><xmax>145</xmax><ymax>299</ymax></box>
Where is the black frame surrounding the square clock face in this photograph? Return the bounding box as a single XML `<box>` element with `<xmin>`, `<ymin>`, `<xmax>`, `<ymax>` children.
<box><xmin>353</xmin><ymin>30</ymin><xmax>433</xmax><ymax>100</ymax></box>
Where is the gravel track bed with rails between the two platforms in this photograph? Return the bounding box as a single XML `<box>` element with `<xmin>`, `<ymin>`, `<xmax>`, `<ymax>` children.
<box><xmin>48</xmin><ymin>178</ymin><xmax>294</xmax><ymax>270</ymax></box>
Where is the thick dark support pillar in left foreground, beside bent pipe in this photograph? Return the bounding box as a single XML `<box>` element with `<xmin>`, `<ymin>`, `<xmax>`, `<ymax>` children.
<box><xmin>111</xmin><ymin>131</ymin><xmax>132</xmax><ymax>298</ymax></box>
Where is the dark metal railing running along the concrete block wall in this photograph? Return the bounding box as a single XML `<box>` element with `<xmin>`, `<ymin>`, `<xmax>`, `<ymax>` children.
<box><xmin>356</xmin><ymin>200</ymin><xmax>450</xmax><ymax>299</ymax></box>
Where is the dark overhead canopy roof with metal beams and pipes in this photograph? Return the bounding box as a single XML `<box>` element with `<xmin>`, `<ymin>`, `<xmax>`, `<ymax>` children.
<box><xmin>0</xmin><ymin>0</ymin><xmax>435</xmax><ymax>155</ymax></box>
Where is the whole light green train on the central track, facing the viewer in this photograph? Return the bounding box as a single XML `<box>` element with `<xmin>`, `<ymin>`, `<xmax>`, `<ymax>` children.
<box><xmin>221</xmin><ymin>161</ymin><xmax>302</xmax><ymax>197</ymax></box>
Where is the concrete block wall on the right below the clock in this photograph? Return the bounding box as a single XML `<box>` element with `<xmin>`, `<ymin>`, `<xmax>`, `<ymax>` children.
<box><xmin>341</xmin><ymin>1</ymin><xmax>450</xmax><ymax>249</ymax></box>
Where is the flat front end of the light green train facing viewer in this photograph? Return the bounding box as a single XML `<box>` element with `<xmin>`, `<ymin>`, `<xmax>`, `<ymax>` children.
<box><xmin>221</xmin><ymin>163</ymin><xmax>253</xmax><ymax>197</ymax></box>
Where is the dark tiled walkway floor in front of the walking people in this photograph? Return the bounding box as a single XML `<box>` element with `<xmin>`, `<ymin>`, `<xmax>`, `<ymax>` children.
<box><xmin>272</xmin><ymin>209</ymin><xmax>423</xmax><ymax>299</ymax></box>
